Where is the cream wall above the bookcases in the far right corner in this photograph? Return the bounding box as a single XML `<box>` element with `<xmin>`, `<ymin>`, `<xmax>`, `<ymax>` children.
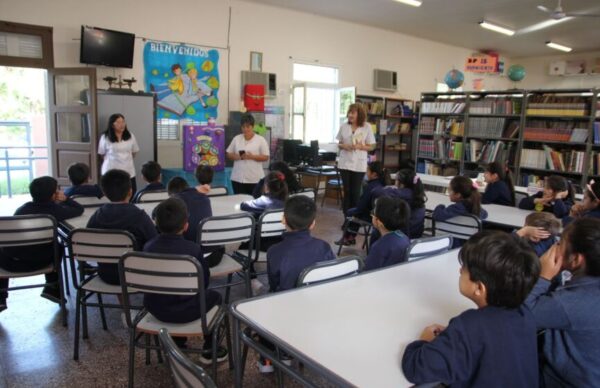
<box><xmin>513</xmin><ymin>51</ymin><xmax>600</xmax><ymax>89</ymax></box>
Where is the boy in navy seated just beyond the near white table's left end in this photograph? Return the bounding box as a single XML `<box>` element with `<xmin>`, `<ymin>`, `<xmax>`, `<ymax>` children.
<box><xmin>258</xmin><ymin>195</ymin><xmax>336</xmax><ymax>373</ymax></box>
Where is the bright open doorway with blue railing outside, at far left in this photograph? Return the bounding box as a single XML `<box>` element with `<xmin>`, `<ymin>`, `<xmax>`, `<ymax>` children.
<box><xmin>0</xmin><ymin>66</ymin><xmax>50</xmax><ymax>206</ymax></box>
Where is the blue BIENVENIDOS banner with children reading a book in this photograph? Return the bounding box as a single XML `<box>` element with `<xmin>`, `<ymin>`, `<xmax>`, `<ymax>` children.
<box><xmin>144</xmin><ymin>41</ymin><xmax>220</xmax><ymax>122</ymax></box>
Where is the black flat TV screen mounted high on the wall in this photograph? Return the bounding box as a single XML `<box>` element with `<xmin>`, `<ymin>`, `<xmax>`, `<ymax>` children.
<box><xmin>79</xmin><ymin>26</ymin><xmax>135</xmax><ymax>69</ymax></box>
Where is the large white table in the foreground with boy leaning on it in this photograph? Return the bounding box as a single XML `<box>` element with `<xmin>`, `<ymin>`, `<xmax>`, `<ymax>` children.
<box><xmin>230</xmin><ymin>250</ymin><xmax>468</xmax><ymax>388</ymax></box>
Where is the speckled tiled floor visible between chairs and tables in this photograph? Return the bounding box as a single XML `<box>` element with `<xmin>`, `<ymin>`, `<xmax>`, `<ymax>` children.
<box><xmin>0</xmin><ymin>200</ymin><xmax>364</xmax><ymax>387</ymax></box>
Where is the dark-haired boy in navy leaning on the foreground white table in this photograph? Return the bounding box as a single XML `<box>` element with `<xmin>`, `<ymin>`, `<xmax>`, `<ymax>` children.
<box><xmin>402</xmin><ymin>230</ymin><xmax>540</xmax><ymax>388</ymax></box>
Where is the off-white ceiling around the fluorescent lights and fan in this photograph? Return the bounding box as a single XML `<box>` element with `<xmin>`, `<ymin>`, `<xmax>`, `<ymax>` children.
<box><xmin>243</xmin><ymin>0</ymin><xmax>600</xmax><ymax>57</ymax></box>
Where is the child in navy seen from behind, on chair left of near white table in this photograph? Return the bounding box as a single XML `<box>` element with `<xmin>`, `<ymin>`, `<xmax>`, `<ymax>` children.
<box><xmin>144</xmin><ymin>198</ymin><xmax>227</xmax><ymax>364</ymax></box>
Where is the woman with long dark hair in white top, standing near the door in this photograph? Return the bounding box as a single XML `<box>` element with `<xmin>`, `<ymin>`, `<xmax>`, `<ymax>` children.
<box><xmin>98</xmin><ymin>113</ymin><xmax>140</xmax><ymax>193</ymax></box>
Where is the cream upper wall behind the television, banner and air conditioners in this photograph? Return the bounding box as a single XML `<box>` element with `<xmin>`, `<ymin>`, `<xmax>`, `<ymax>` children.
<box><xmin>0</xmin><ymin>0</ymin><xmax>510</xmax><ymax>165</ymax></box>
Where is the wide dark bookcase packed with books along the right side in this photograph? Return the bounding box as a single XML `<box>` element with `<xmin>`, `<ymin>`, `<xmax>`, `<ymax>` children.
<box><xmin>415</xmin><ymin>89</ymin><xmax>600</xmax><ymax>186</ymax></box>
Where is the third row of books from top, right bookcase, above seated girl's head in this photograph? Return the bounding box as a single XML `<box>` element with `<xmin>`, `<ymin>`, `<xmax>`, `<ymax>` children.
<box><xmin>521</xmin><ymin>145</ymin><xmax>585</xmax><ymax>173</ymax></box>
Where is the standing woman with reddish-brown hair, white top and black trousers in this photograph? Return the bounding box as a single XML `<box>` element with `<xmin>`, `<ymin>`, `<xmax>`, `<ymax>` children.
<box><xmin>336</xmin><ymin>104</ymin><xmax>375</xmax><ymax>214</ymax></box>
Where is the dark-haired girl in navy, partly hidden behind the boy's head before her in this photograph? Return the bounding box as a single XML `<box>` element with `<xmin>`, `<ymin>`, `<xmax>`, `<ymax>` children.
<box><xmin>371</xmin><ymin>168</ymin><xmax>425</xmax><ymax>239</ymax></box>
